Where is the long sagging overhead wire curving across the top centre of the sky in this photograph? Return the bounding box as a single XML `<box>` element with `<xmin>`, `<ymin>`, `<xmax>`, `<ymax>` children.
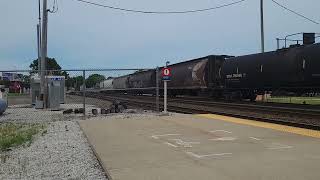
<box><xmin>75</xmin><ymin>0</ymin><xmax>246</xmax><ymax>14</ymax></box>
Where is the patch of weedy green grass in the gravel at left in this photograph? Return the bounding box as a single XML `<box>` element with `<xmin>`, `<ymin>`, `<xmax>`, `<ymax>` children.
<box><xmin>0</xmin><ymin>123</ymin><xmax>45</xmax><ymax>151</ymax></box>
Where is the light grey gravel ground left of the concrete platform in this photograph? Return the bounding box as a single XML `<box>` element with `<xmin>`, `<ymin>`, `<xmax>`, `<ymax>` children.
<box><xmin>0</xmin><ymin>104</ymin><xmax>107</xmax><ymax>180</ymax></box>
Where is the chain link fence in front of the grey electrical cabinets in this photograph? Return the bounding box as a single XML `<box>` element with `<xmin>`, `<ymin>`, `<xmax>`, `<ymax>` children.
<box><xmin>0</xmin><ymin>68</ymin><xmax>160</xmax><ymax>121</ymax></box>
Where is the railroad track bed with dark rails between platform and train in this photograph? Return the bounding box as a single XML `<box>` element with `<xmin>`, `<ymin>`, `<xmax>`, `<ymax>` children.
<box><xmin>70</xmin><ymin>92</ymin><xmax>320</xmax><ymax>130</ymax></box>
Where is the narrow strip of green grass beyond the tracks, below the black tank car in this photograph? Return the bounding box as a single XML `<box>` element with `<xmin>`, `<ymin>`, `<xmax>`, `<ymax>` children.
<box><xmin>267</xmin><ymin>97</ymin><xmax>320</xmax><ymax>105</ymax></box>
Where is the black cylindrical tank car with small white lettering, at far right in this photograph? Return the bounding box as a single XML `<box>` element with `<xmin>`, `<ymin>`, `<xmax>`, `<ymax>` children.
<box><xmin>222</xmin><ymin>44</ymin><xmax>320</xmax><ymax>99</ymax></box>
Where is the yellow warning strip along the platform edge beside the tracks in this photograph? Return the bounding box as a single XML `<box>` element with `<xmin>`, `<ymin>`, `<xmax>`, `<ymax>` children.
<box><xmin>197</xmin><ymin>114</ymin><xmax>320</xmax><ymax>138</ymax></box>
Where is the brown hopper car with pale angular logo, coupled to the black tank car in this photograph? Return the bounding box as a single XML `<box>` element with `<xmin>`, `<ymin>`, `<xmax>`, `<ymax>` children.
<box><xmin>159</xmin><ymin>55</ymin><xmax>231</xmax><ymax>96</ymax></box>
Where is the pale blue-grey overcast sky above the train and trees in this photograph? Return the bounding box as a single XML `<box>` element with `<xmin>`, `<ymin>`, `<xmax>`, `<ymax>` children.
<box><xmin>0</xmin><ymin>0</ymin><xmax>320</xmax><ymax>70</ymax></box>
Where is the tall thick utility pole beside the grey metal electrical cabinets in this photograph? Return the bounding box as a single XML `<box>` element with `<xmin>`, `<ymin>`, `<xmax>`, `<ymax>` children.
<box><xmin>40</xmin><ymin>0</ymin><xmax>48</xmax><ymax>109</ymax></box>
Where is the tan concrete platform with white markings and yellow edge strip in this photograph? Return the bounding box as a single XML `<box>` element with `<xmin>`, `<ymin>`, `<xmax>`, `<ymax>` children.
<box><xmin>80</xmin><ymin>114</ymin><xmax>320</xmax><ymax>180</ymax></box>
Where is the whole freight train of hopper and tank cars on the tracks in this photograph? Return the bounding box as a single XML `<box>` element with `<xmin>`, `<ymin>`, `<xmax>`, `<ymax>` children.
<box><xmin>101</xmin><ymin>43</ymin><xmax>320</xmax><ymax>100</ymax></box>
